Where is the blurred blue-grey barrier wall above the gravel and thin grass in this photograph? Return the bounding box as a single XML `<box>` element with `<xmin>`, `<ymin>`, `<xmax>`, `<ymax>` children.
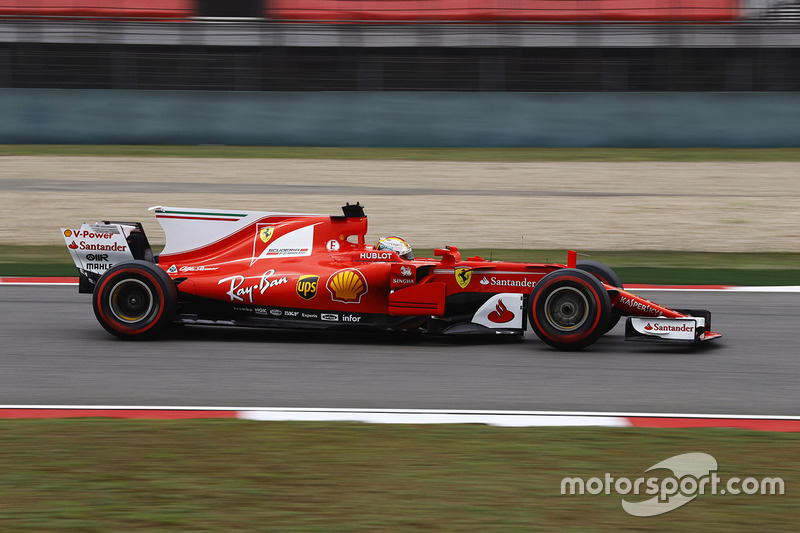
<box><xmin>0</xmin><ymin>89</ymin><xmax>800</xmax><ymax>147</ymax></box>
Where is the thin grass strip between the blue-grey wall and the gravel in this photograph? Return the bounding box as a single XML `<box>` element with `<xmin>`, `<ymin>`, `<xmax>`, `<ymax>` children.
<box><xmin>0</xmin><ymin>144</ymin><xmax>800</xmax><ymax>162</ymax></box>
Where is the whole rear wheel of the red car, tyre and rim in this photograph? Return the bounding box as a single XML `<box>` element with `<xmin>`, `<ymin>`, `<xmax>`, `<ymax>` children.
<box><xmin>92</xmin><ymin>261</ymin><xmax>178</xmax><ymax>340</ymax></box>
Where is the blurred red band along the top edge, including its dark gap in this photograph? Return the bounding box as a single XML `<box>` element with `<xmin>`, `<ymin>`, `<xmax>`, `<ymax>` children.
<box><xmin>0</xmin><ymin>0</ymin><xmax>740</xmax><ymax>23</ymax></box>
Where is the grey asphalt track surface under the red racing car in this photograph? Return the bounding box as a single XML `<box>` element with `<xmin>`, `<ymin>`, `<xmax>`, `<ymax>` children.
<box><xmin>0</xmin><ymin>286</ymin><xmax>800</xmax><ymax>416</ymax></box>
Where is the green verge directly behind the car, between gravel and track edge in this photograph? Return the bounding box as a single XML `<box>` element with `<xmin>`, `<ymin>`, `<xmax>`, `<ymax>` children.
<box><xmin>6</xmin><ymin>244</ymin><xmax>800</xmax><ymax>285</ymax></box>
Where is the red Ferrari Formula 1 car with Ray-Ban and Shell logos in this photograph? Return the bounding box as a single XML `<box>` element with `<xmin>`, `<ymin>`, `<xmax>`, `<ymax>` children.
<box><xmin>62</xmin><ymin>204</ymin><xmax>721</xmax><ymax>350</ymax></box>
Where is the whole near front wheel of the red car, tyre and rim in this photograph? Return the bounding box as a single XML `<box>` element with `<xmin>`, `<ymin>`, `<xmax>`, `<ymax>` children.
<box><xmin>528</xmin><ymin>268</ymin><xmax>611</xmax><ymax>350</ymax></box>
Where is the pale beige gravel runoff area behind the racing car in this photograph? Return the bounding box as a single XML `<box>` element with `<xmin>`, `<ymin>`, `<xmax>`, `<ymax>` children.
<box><xmin>0</xmin><ymin>156</ymin><xmax>800</xmax><ymax>252</ymax></box>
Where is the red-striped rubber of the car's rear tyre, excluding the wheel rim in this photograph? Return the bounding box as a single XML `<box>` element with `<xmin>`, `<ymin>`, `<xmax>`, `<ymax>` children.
<box><xmin>92</xmin><ymin>261</ymin><xmax>177</xmax><ymax>339</ymax></box>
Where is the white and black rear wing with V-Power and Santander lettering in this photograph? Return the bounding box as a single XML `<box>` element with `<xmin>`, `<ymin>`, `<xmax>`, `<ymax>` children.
<box><xmin>61</xmin><ymin>220</ymin><xmax>156</xmax><ymax>293</ymax></box>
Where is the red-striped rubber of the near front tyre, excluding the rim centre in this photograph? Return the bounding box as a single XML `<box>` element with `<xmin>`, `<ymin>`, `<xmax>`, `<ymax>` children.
<box><xmin>528</xmin><ymin>269</ymin><xmax>611</xmax><ymax>350</ymax></box>
